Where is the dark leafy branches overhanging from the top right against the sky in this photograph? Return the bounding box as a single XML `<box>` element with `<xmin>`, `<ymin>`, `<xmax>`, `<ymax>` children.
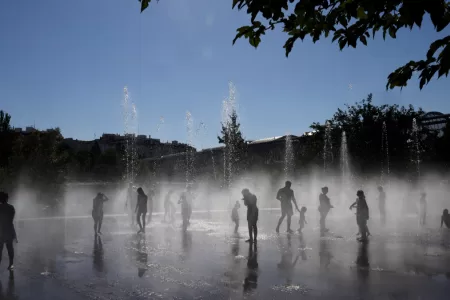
<box><xmin>139</xmin><ymin>0</ymin><xmax>450</xmax><ymax>89</ymax></box>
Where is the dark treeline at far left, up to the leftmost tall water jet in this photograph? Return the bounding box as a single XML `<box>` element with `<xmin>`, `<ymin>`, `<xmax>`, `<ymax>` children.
<box><xmin>0</xmin><ymin>111</ymin><xmax>124</xmax><ymax>203</ymax></box>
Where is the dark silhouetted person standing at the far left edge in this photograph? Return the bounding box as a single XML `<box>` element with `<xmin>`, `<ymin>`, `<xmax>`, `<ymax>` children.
<box><xmin>0</xmin><ymin>192</ymin><xmax>17</xmax><ymax>270</ymax></box>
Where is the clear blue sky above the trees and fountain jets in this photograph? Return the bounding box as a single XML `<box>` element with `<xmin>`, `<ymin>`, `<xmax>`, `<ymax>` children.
<box><xmin>0</xmin><ymin>0</ymin><xmax>450</xmax><ymax>147</ymax></box>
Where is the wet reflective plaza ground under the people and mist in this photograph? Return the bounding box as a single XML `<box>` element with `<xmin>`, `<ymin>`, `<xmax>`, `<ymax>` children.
<box><xmin>0</xmin><ymin>211</ymin><xmax>450</xmax><ymax>300</ymax></box>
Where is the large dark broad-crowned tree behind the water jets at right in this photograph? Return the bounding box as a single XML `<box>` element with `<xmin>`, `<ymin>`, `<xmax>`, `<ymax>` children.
<box><xmin>311</xmin><ymin>94</ymin><xmax>431</xmax><ymax>174</ymax></box>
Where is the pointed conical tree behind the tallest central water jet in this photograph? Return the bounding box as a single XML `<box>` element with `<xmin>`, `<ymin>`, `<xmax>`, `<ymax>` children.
<box><xmin>217</xmin><ymin>110</ymin><xmax>247</xmax><ymax>185</ymax></box>
